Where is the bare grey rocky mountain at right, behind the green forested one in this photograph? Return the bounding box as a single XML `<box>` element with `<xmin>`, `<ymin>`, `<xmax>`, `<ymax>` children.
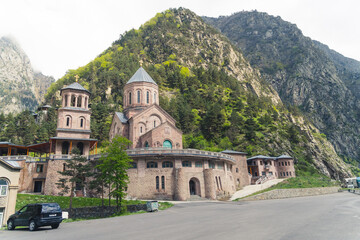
<box><xmin>204</xmin><ymin>11</ymin><xmax>360</xmax><ymax>165</ymax></box>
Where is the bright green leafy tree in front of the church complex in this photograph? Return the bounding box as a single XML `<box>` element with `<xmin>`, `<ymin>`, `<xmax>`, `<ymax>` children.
<box><xmin>97</xmin><ymin>136</ymin><xmax>132</xmax><ymax>211</ymax></box>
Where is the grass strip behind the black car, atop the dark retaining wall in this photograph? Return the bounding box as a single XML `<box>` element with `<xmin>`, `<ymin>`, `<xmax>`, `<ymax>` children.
<box><xmin>16</xmin><ymin>194</ymin><xmax>146</xmax><ymax>211</ymax></box>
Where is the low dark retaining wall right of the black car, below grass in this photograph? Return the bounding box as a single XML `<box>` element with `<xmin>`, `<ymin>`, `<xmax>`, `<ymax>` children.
<box><xmin>63</xmin><ymin>204</ymin><xmax>146</xmax><ymax>218</ymax></box>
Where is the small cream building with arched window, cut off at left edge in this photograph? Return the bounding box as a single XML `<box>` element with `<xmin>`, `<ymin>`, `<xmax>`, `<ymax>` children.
<box><xmin>0</xmin><ymin>159</ymin><xmax>21</xmax><ymax>227</ymax></box>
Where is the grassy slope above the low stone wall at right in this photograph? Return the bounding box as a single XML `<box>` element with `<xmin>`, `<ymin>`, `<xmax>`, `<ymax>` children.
<box><xmin>234</xmin><ymin>175</ymin><xmax>340</xmax><ymax>201</ymax></box>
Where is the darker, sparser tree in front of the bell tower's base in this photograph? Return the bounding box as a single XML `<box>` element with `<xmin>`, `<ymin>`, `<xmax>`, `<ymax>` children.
<box><xmin>56</xmin><ymin>148</ymin><xmax>92</xmax><ymax>214</ymax></box>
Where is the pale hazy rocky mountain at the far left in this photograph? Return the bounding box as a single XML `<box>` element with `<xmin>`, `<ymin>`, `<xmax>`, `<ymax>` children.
<box><xmin>0</xmin><ymin>37</ymin><xmax>54</xmax><ymax>113</ymax></box>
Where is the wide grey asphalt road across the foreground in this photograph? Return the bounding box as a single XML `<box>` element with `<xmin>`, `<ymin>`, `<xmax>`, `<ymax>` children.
<box><xmin>0</xmin><ymin>192</ymin><xmax>360</xmax><ymax>240</ymax></box>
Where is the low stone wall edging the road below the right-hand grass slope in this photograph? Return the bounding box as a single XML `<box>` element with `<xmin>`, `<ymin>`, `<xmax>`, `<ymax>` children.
<box><xmin>244</xmin><ymin>187</ymin><xmax>339</xmax><ymax>201</ymax></box>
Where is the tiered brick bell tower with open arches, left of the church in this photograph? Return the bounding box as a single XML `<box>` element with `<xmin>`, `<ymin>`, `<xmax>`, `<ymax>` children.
<box><xmin>50</xmin><ymin>79</ymin><xmax>97</xmax><ymax>155</ymax></box>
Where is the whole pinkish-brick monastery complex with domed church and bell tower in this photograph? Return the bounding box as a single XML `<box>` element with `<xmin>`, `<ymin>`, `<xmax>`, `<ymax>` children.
<box><xmin>0</xmin><ymin>67</ymin><xmax>295</xmax><ymax>204</ymax></box>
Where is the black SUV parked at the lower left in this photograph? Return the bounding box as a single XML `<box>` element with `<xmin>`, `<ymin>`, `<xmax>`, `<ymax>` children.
<box><xmin>7</xmin><ymin>203</ymin><xmax>63</xmax><ymax>231</ymax></box>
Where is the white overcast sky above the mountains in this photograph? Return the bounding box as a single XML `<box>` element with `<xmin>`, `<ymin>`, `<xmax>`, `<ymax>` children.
<box><xmin>0</xmin><ymin>0</ymin><xmax>360</xmax><ymax>79</ymax></box>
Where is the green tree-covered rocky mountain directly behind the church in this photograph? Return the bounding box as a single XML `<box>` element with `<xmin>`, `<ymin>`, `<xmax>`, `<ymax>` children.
<box><xmin>41</xmin><ymin>8</ymin><xmax>351</xmax><ymax>179</ymax></box>
